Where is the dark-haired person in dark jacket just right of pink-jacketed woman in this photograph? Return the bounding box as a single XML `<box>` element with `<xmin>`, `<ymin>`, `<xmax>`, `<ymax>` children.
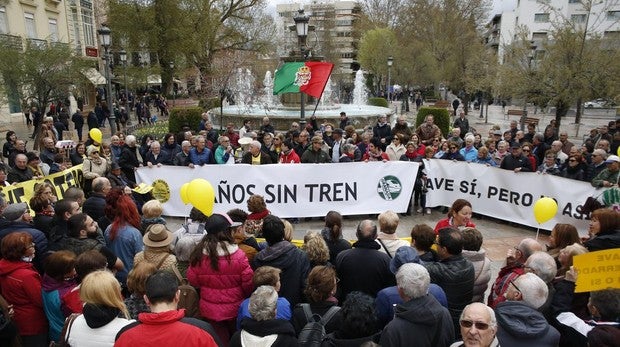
<box><xmin>252</xmin><ymin>215</ymin><xmax>310</xmax><ymax>306</ymax></box>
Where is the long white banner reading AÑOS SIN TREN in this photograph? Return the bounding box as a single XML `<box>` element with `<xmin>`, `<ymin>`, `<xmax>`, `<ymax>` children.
<box><xmin>136</xmin><ymin>161</ymin><xmax>419</xmax><ymax>218</ymax></box>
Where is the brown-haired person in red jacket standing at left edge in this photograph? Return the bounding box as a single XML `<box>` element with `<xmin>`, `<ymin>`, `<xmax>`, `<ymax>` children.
<box><xmin>0</xmin><ymin>232</ymin><xmax>48</xmax><ymax>346</ymax></box>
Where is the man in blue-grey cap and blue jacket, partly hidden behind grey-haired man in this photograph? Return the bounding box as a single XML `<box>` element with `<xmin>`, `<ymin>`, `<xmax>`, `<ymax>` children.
<box><xmin>375</xmin><ymin>249</ymin><xmax>451</xmax><ymax>326</ymax></box>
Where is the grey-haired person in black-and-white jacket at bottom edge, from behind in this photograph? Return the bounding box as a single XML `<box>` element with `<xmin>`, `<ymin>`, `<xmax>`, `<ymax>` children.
<box><xmin>230</xmin><ymin>286</ymin><xmax>297</xmax><ymax>347</ymax></box>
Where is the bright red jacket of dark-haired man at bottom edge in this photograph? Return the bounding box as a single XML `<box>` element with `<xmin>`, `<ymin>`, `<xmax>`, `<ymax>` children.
<box><xmin>114</xmin><ymin>309</ymin><xmax>219</xmax><ymax>347</ymax></box>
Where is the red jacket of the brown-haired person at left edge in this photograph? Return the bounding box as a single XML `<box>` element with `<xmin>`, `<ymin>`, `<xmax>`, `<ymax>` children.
<box><xmin>0</xmin><ymin>259</ymin><xmax>47</xmax><ymax>336</ymax></box>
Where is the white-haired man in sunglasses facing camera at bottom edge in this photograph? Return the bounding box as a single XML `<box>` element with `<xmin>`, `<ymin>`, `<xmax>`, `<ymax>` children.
<box><xmin>450</xmin><ymin>302</ymin><xmax>499</xmax><ymax>347</ymax></box>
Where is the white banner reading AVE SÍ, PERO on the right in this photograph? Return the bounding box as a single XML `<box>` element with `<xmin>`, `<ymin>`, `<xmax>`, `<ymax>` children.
<box><xmin>425</xmin><ymin>159</ymin><xmax>600</xmax><ymax>235</ymax></box>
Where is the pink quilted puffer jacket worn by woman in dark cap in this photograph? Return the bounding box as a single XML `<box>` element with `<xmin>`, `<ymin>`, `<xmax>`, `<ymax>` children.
<box><xmin>187</xmin><ymin>243</ymin><xmax>254</xmax><ymax>322</ymax></box>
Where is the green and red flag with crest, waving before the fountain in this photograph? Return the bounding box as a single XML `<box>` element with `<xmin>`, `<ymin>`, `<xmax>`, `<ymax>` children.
<box><xmin>273</xmin><ymin>61</ymin><xmax>334</xmax><ymax>98</ymax></box>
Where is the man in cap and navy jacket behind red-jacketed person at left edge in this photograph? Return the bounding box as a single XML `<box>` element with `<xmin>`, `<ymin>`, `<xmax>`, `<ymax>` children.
<box><xmin>0</xmin><ymin>203</ymin><xmax>48</xmax><ymax>273</ymax></box>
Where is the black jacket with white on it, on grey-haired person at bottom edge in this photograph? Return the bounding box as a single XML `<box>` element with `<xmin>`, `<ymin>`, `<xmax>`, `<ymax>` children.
<box><xmin>230</xmin><ymin>318</ymin><xmax>297</xmax><ymax>347</ymax></box>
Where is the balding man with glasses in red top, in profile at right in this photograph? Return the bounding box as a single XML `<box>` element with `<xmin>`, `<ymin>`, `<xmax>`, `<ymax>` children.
<box><xmin>488</xmin><ymin>238</ymin><xmax>542</xmax><ymax>308</ymax></box>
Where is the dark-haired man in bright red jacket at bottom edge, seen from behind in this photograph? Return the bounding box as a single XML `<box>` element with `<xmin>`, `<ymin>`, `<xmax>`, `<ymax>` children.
<box><xmin>114</xmin><ymin>270</ymin><xmax>222</xmax><ymax>347</ymax></box>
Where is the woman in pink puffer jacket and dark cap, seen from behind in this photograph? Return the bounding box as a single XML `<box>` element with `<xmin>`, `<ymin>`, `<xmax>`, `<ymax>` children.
<box><xmin>187</xmin><ymin>213</ymin><xmax>254</xmax><ymax>343</ymax></box>
